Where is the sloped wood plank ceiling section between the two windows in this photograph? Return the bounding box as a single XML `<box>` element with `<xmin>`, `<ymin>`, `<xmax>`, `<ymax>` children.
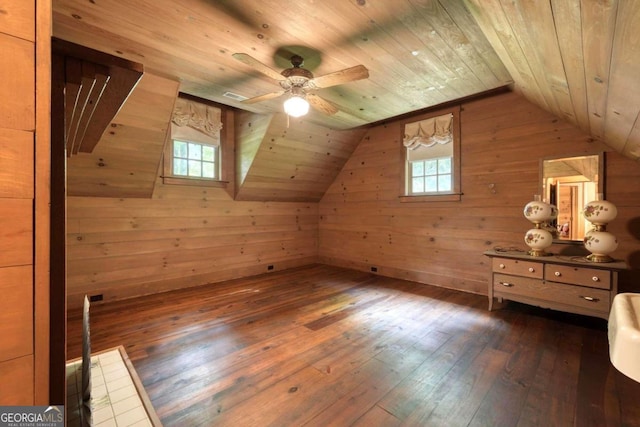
<box><xmin>235</xmin><ymin>112</ymin><xmax>365</xmax><ymax>201</ymax></box>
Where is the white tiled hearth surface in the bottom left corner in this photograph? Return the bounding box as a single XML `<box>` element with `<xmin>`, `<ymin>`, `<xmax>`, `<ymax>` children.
<box><xmin>67</xmin><ymin>349</ymin><xmax>152</xmax><ymax>427</ymax></box>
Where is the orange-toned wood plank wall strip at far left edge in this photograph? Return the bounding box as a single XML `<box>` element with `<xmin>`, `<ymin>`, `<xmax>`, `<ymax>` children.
<box><xmin>0</xmin><ymin>0</ymin><xmax>51</xmax><ymax>405</ymax></box>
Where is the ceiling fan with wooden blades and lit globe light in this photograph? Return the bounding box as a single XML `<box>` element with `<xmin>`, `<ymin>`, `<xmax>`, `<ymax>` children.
<box><xmin>233</xmin><ymin>53</ymin><xmax>369</xmax><ymax>117</ymax></box>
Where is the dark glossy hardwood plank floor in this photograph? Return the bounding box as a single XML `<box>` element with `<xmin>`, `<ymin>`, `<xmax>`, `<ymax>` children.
<box><xmin>68</xmin><ymin>265</ymin><xmax>640</xmax><ymax>427</ymax></box>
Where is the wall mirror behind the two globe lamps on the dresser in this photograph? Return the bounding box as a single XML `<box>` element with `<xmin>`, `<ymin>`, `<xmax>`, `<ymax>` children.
<box><xmin>540</xmin><ymin>153</ymin><xmax>604</xmax><ymax>242</ymax></box>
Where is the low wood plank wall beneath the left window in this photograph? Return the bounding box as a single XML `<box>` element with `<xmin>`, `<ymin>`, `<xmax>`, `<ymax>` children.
<box><xmin>67</xmin><ymin>170</ymin><xmax>318</xmax><ymax>308</ymax></box>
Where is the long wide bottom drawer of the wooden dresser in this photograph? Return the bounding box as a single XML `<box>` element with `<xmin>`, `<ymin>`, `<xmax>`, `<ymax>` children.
<box><xmin>493</xmin><ymin>273</ymin><xmax>611</xmax><ymax>313</ymax></box>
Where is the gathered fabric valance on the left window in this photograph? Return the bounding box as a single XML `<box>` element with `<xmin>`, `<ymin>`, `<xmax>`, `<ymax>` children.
<box><xmin>171</xmin><ymin>98</ymin><xmax>222</xmax><ymax>145</ymax></box>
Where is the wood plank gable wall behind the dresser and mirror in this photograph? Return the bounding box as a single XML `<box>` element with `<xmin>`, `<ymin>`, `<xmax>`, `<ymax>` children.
<box><xmin>319</xmin><ymin>93</ymin><xmax>640</xmax><ymax>294</ymax></box>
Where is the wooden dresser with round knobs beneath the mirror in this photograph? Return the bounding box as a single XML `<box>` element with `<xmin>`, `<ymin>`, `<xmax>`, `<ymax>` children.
<box><xmin>484</xmin><ymin>250</ymin><xmax>627</xmax><ymax>319</ymax></box>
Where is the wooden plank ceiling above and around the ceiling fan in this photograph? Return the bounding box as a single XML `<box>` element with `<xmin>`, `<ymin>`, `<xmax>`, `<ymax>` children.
<box><xmin>53</xmin><ymin>0</ymin><xmax>640</xmax><ymax>200</ymax></box>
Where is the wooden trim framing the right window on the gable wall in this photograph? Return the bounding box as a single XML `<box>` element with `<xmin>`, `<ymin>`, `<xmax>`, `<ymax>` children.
<box><xmin>399</xmin><ymin>106</ymin><xmax>462</xmax><ymax>202</ymax></box>
